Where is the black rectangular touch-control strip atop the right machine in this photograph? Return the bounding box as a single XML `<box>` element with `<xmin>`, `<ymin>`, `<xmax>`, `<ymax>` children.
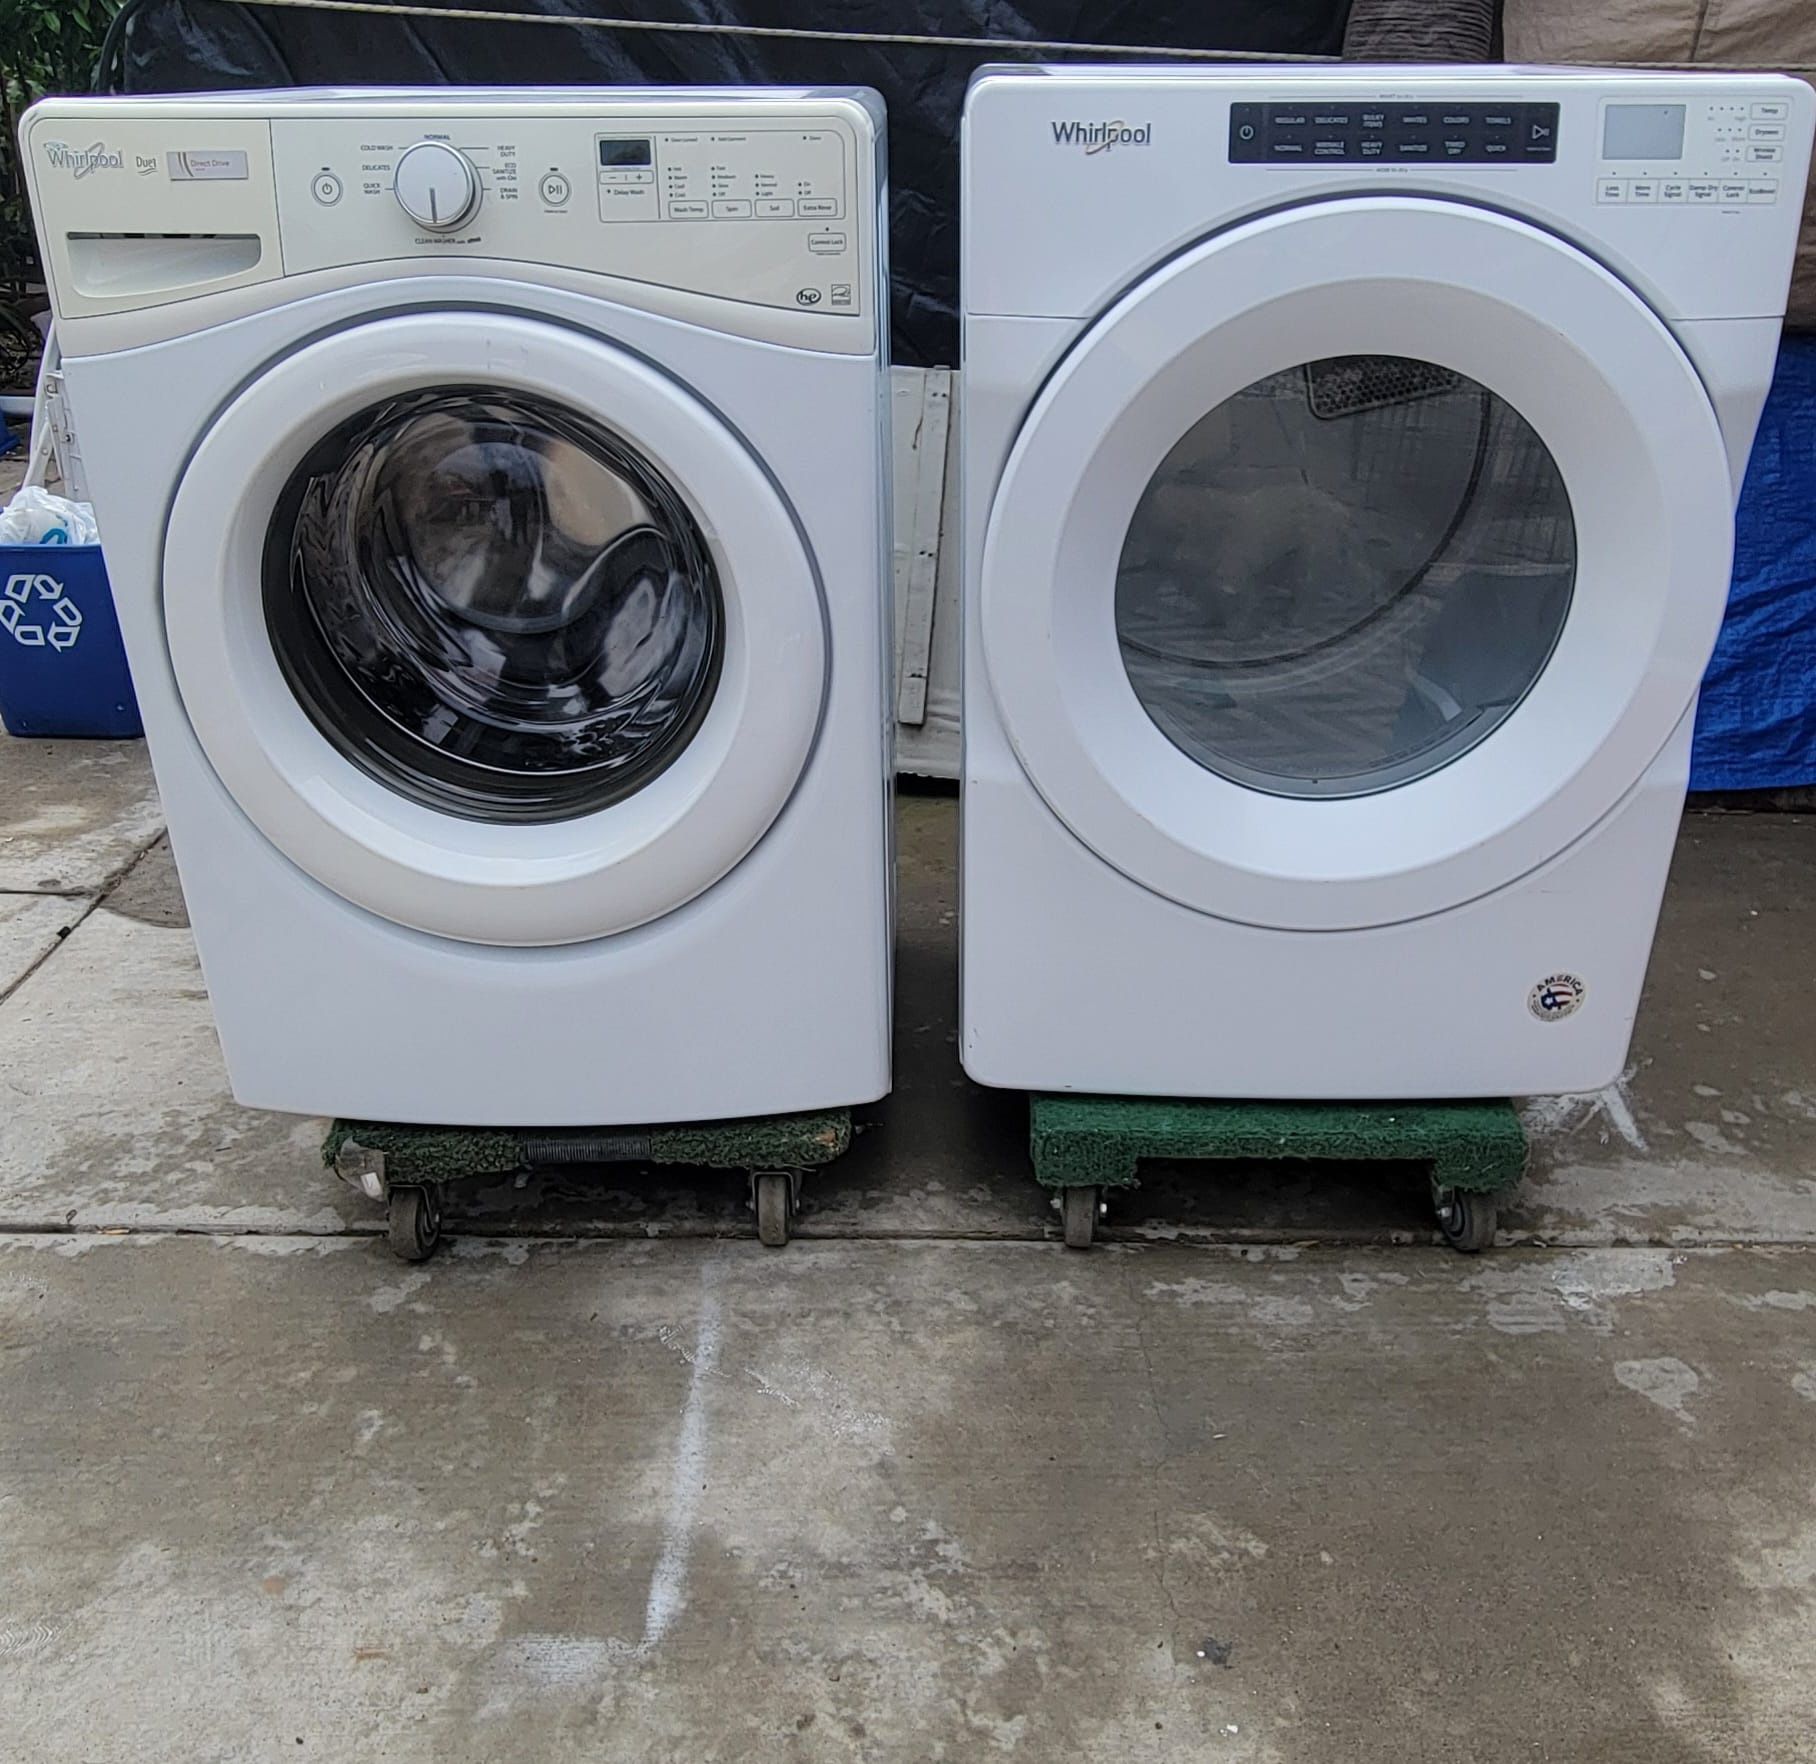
<box><xmin>1229</xmin><ymin>102</ymin><xmax>1558</xmax><ymax>165</ymax></box>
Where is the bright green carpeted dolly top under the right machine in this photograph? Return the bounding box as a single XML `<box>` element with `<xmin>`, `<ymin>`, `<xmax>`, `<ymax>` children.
<box><xmin>1028</xmin><ymin>1095</ymin><xmax>1525</xmax><ymax>1194</ymax></box>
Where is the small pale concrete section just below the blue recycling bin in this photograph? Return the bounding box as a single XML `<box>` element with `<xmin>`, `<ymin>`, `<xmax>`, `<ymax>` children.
<box><xmin>0</xmin><ymin>736</ymin><xmax>163</xmax><ymax>894</ymax></box>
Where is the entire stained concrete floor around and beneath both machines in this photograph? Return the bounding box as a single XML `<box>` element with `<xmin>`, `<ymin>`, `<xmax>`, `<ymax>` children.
<box><xmin>0</xmin><ymin>741</ymin><xmax>1816</xmax><ymax>1764</ymax></box>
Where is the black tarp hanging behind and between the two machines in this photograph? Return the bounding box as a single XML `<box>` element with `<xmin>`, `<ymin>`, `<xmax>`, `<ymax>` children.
<box><xmin>104</xmin><ymin>0</ymin><xmax>1349</xmax><ymax>365</ymax></box>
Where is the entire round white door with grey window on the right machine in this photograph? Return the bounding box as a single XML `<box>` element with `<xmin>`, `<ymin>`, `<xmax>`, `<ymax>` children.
<box><xmin>979</xmin><ymin>198</ymin><xmax>1732</xmax><ymax>930</ymax></box>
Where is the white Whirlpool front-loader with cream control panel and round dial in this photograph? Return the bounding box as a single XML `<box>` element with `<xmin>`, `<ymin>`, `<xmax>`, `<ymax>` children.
<box><xmin>22</xmin><ymin>89</ymin><xmax>892</xmax><ymax>1126</ymax></box>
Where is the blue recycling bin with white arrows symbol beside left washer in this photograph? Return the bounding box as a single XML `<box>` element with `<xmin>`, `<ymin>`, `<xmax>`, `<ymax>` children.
<box><xmin>0</xmin><ymin>545</ymin><xmax>145</xmax><ymax>738</ymax></box>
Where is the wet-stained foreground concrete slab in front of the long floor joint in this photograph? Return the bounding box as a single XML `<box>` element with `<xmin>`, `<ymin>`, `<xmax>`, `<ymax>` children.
<box><xmin>0</xmin><ymin>1237</ymin><xmax>1816</xmax><ymax>1764</ymax></box>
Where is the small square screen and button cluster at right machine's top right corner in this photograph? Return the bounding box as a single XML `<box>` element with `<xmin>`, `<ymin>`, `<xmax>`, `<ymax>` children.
<box><xmin>1594</xmin><ymin>96</ymin><xmax>1803</xmax><ymax>209</ymax></box>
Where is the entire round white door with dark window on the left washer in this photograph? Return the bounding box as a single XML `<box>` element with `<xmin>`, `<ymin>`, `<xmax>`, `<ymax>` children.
<box><xmin>163</xmin><ymin>312</ymin><xmax>826</xmax><ymax>945</ymax></box>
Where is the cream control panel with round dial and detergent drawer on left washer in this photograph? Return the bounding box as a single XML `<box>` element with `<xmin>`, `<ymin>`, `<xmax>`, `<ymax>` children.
<box><xmin>25</xmin><ymin>89</ymin><xmax>886</xmax><ymax>339</ymax></box>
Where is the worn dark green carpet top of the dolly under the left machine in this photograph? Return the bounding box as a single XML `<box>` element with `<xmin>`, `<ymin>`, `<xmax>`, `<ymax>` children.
<box><xmin>321</xmin><ymin>1108</ymin><xmax>852</xmax><ymax>1184</ymax></box>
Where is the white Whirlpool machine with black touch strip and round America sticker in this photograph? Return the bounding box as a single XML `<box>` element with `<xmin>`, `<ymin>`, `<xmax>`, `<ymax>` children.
<box><xmin>962</xmin><ymin>67</ymin><xmax>1812</xmax><ymax>1099</ymax></box>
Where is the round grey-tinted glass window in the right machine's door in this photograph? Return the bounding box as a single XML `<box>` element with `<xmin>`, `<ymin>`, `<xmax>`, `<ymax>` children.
<box><xmin>1115</xmin><ymin>356</ymin><xmax>1576</xmax><ymax>798</ymax></box>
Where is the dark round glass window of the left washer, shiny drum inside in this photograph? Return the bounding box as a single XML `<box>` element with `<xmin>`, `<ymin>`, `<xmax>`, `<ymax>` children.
<box><xmin>263</xmin><ymin>387</ymin><xmax>725</xmax><ymax>821</ymax></box>
